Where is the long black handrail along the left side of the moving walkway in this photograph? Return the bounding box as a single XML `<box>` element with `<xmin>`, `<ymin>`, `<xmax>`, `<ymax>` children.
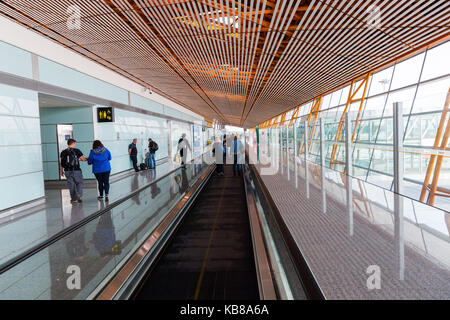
<box><xmin>0</xmin><ymin>154</ymin><xmax>210</xmax><ymax>275</ymax></box>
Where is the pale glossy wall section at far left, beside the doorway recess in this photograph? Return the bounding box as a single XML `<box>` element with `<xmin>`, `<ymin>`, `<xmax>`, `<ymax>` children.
<box><xmin>0</xmin><ymin>84</ymin><xmax>44</xmax><ymax>210</ymax></box>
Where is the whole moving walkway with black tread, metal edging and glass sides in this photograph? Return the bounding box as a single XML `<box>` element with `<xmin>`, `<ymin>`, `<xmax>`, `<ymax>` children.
<box><xmin>0</xmin><ymin>156</ymin><xmax>307</xmax><ymax>300</ymax></box>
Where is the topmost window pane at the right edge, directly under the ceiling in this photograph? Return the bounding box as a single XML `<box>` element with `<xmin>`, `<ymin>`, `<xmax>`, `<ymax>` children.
<box><xmin>421</xmin><ymin>41</ymin><xmax>450</xmax><ymax>81</ymax></box>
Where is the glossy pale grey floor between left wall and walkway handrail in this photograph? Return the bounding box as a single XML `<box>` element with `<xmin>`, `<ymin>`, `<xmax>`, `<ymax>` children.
<box><xmin>0</xmin><ymin>162</ymin><xmax>178</xmax><ymax>264</ymax></box>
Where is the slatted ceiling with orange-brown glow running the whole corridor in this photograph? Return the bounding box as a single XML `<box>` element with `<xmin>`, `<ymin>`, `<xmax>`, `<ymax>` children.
<box><xmin>0</xmin><ymin>0</ymin><xmax>450</xmax><ymax>127</ymax></box>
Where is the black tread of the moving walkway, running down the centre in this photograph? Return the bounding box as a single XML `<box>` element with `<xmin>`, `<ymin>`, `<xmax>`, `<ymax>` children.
<box><xmin>134</xmin><ymin>165</ymin><xmax>259</xmax><ymax>300</ymax></box>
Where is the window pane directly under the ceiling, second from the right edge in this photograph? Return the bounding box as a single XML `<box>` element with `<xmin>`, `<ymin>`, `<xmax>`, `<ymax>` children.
<box><xmin>391</xmin><ymin>53</ymin><xmax>425</xmax><ymax>90</ymax></box>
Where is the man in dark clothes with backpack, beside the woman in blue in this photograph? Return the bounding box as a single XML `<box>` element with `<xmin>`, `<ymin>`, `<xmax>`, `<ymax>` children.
<box><xmin>59</xmin><ymin>139</ymin><xmax>87</xmax><ymax>204</ymax></box>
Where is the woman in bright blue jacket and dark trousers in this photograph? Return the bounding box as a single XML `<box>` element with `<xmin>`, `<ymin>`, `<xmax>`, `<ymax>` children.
<box><xmin>88</xmin><ymin>140</ymin><xmax>111</xmax><ymax>201</ymax></box>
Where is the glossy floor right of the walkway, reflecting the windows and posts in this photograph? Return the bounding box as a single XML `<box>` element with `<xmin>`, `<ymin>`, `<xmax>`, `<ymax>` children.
<box><xmin>253</xmin><ymin>149</ymin><xmax>450</xmax><ymax>299</ymax></box>
